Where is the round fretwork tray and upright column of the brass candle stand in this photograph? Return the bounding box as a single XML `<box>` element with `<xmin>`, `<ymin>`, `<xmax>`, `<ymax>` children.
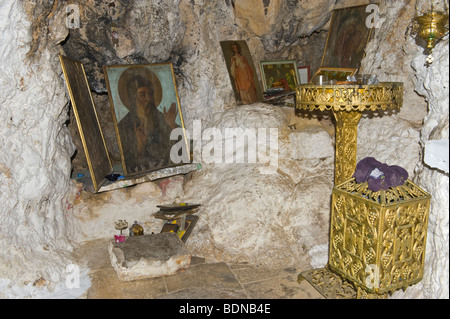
<box><xmin>295</xmin><ymin>82</ymin><xmax>403</xmax><ymax>185</ymax></box>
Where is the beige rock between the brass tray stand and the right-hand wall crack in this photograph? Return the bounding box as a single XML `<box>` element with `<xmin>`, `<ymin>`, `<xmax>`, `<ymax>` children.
<box><xmin>357</xmin><ymin>0</ymin><xmax>426</xmax><ymax>178</ymax></box>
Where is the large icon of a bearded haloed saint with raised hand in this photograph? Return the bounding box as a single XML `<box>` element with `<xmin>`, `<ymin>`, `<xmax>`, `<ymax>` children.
<box><xmin>103</xmin><ymin>63</ymin><xmax>190</xmax><ymax>176</ymax></box>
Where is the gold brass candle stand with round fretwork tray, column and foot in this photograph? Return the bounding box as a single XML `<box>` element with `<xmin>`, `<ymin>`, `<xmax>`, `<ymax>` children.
<box><xmin>295</xmin><ymin>82</ymin><xmax>403</xmax><ymax>298</ymax></box>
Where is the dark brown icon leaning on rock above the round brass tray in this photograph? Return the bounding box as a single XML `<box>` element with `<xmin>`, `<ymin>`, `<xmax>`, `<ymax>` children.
<box><xmin>321</xmin><ymin>5</ymin><xmax>373</xmax><ymax>68</ymax></box>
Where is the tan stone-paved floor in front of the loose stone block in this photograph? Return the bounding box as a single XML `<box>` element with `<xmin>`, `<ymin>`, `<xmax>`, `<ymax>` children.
<box><xmin>74</xmin><ymin>240</ymin><xmax>323</xmax><ymax>299</ymax></box>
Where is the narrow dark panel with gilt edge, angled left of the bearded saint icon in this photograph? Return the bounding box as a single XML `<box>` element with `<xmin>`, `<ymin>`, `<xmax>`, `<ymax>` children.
<box><xmin>59</xmin><ymin>55</ymin><xmax>113</xmax><ymax>191</ymax></box>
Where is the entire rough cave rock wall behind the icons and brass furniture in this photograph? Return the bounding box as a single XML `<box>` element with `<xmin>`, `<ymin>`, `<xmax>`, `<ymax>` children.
<box><xmin>0</xmin><ymin>0</ymin><xmax>448</xmax><ymax>298</ymax></box>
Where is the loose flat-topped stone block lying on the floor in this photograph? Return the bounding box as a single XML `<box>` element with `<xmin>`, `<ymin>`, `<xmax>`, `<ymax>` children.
<box><xmin>108</xmin><ymin>233</ymin><xmax>191</xmax><ymax>281</ymax></box>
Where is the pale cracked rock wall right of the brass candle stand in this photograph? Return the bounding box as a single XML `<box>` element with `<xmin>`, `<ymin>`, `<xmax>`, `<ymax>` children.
<box><xmin>358</xmin><ymin>0</ymin><xmax>449</xmax><ymax>298</ymax></box>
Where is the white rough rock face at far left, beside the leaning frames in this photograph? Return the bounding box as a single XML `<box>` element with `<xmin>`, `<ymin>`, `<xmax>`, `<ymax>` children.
<box><xmin>0</xmin><ymin>1</ymin><xmax>74</xmax><ymax>284</ymax></box>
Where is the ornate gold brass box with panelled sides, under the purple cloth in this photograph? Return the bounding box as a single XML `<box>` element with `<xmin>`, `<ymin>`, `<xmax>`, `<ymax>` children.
<box><xmin>328</xmin><ymin>178</ymin><xmax>431</xmax><ymax>296</ymax></box>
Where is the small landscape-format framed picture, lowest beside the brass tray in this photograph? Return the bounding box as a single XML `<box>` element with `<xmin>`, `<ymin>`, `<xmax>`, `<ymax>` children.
<box><xmin>259</xmin><ymin>60</ymin><xmax>299</xmax><ymax>93</ymax></box>
